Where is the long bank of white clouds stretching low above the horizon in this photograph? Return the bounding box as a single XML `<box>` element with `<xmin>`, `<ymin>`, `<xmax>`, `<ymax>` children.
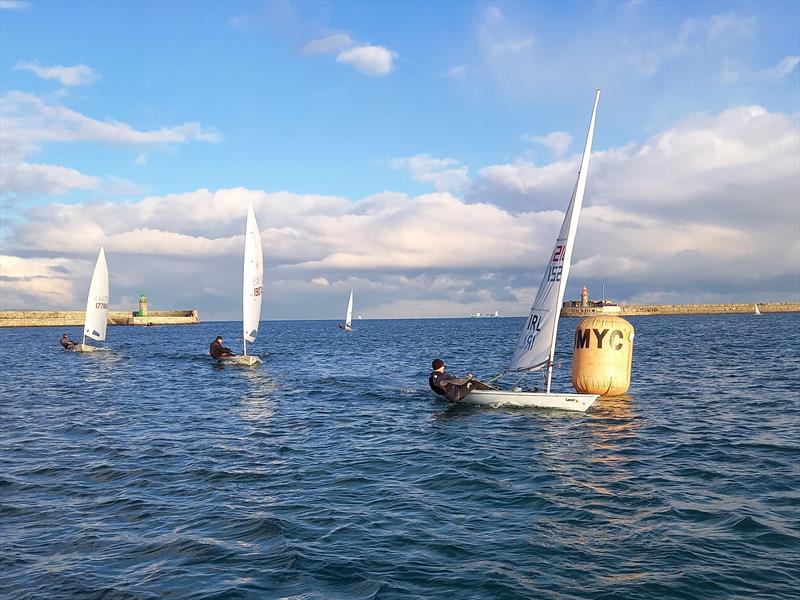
<box><xmin>4</xmin><ymin>106</ymin><xmax>800</xmax><ymax>319</ymax></box>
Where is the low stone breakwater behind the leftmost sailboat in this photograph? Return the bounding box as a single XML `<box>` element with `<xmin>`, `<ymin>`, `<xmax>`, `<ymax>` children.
<box><xmin>0</xmin><ymin>309</ymin><xmax>200</xmax><ymax>327</ymax></box>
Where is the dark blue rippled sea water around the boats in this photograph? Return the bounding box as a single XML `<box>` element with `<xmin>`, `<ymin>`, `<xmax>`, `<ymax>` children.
<box><xmin>0</xmin><ymin>315</ymin><xmax>800</xmax><ymax>599</ymax></box>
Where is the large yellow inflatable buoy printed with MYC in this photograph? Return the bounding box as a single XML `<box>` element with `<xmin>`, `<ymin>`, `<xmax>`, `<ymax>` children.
<box><xmin>572</xmin><ymin>315</ymin><xmax>634</xmax><ymax>396</ymax></box>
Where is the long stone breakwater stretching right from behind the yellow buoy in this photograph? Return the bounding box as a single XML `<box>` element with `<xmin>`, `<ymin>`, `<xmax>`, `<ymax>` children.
<box><xmin>561</xmin><ymin>302</ymin><xmax>800</xmax><ymax>317</ymax></box>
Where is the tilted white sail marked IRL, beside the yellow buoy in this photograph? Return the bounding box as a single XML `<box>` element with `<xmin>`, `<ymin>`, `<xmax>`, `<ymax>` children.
<box><xmin>508</xmin><ymin>90</ymin><xmax>600</xmax><ymax>392</ymax></box>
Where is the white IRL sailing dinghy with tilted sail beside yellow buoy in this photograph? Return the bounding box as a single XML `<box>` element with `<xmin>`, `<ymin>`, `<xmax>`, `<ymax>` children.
<box><xmin>461</xmin><ymin>90</ymin><xmax>600</xmax><ymax>412</ymax></box>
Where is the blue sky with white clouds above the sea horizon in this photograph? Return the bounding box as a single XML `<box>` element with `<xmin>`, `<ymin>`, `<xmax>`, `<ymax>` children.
<box><xmin>0</xmin><ymin>0</ymin><xmax>800</xmax><ymax>320</ymax></box>
